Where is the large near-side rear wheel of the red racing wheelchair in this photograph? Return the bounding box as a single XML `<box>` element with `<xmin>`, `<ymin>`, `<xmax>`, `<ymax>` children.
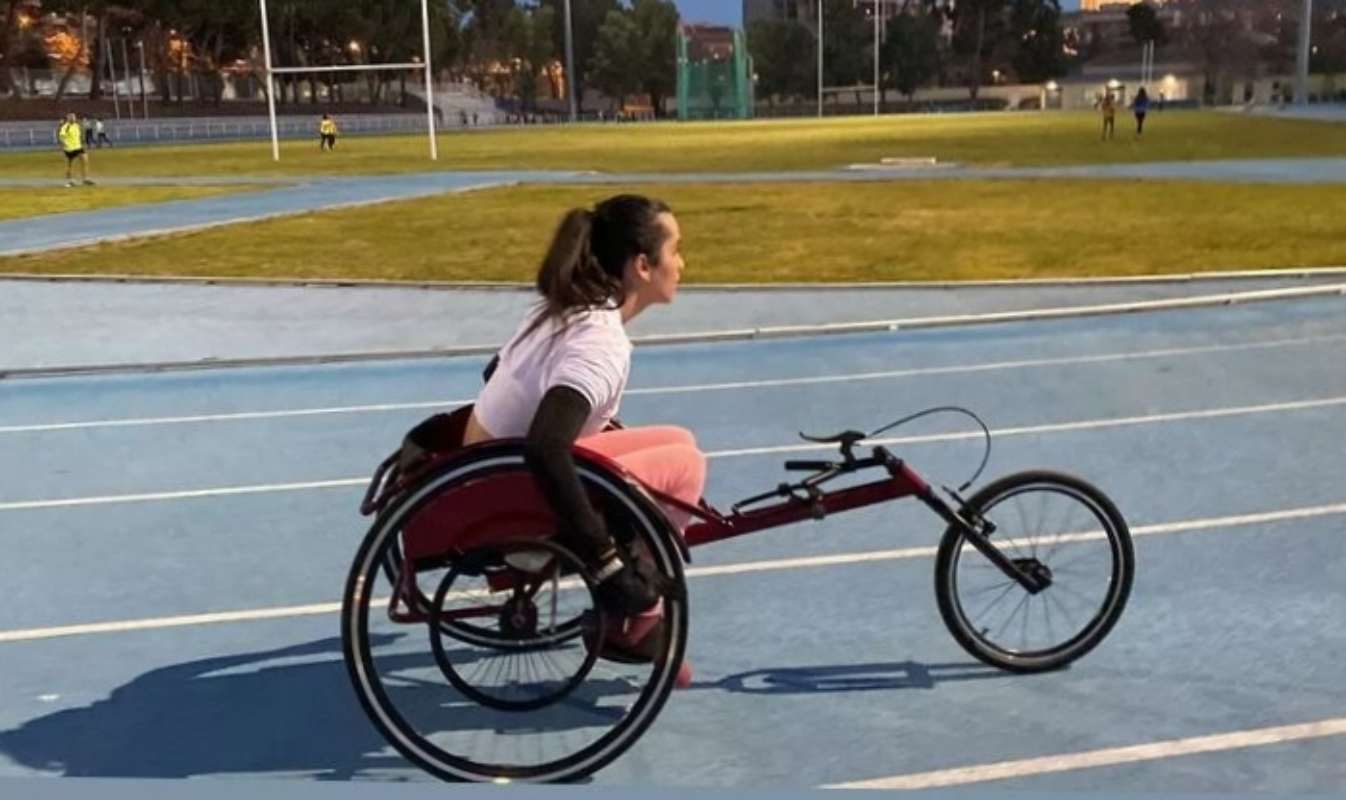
<box><xmin>342</xmin><ymin>447</ymin><xmax>688</xmax><ymax>781</ymax></box>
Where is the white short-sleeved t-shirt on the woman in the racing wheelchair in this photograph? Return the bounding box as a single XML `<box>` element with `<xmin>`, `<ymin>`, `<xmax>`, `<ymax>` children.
<box><xmin>474</xmin><ymin>308</ymin><xmax>631</xmax><ymax>439</ymax></box>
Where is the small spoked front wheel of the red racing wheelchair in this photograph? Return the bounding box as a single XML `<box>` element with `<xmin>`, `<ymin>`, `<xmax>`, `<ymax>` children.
<box><xmin>934</xmin><ymin>471</ymin><xmax>1135</xmax><ymax>672</ymax></box>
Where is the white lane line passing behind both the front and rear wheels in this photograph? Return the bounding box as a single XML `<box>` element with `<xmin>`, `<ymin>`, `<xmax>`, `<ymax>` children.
<box><xmin>0</xmin><ymin>502</ymin><xmax>1346</xmax><ymax>644</ymax></box>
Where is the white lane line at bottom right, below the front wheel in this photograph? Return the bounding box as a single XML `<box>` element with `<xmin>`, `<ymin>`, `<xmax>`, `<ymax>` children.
<box><xmin>824</xmin><ymin>716</ymin><xmax>1346</xmax><ymax>789</ymax></box>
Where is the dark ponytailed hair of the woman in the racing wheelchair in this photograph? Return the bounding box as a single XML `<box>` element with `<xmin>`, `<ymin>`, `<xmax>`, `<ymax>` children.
<box><xmin>528</xmin><ymin>194</ymin><xmax>672</xmax><ymax>340</ymax></box>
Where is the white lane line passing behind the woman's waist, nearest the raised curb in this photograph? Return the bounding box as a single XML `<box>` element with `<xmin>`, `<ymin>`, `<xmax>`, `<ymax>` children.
<box><xmin>0</xmin><ymin>334</ymin><xmax>1346</xmax><ymax>434</ymax></box>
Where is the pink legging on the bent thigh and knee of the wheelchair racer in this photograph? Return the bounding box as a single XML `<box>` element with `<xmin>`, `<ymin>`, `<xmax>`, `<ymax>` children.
<box><xmin>576</xmin><ymin>426</ymin><xmax>705</xmax><ymax>531</ymax></box>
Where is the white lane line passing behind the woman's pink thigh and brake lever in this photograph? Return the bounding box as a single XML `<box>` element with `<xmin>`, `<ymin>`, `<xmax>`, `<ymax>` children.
<box><xmin>0</xmin><ymin>396</ymin><xmax>1346</xmax><ymax>512</ymax></box>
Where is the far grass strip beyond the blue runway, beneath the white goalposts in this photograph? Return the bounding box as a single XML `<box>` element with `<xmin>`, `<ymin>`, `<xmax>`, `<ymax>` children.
<box><xmin>0</xmin><ymin>110</ymin><xmax>1346</xmax><ymax>176</ymax></box>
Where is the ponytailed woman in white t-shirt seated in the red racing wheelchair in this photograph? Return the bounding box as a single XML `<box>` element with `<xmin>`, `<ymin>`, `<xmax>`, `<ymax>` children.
<box><xmin>464</xmin><ymin>195</ymin><xmax>705</xmax><ymax>670</ymax></box>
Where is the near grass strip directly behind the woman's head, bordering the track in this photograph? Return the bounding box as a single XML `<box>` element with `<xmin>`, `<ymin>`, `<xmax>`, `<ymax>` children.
<box><xmin>10</xmin><ymin>180</ymin><xmax>1346</xmax><ymax>283</ymax></box>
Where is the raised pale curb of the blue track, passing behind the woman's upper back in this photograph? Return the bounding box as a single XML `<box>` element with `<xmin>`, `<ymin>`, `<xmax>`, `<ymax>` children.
<box><xmin>0</xmin><ymin>283</ymin><xmax>1346</xmax><ymax>380</ymax></box>
